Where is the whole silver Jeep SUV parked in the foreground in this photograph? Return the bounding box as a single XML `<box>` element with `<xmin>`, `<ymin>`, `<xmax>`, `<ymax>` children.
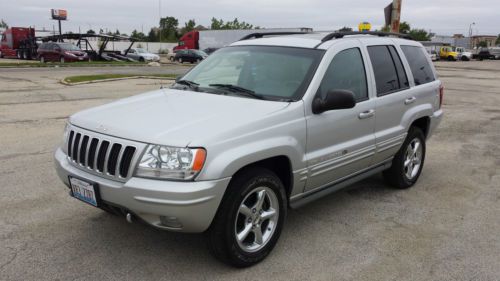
<box><xmin>55</xmin><ymin>33</ymin><xmax>443</xmax><ymax>267</ymax></box>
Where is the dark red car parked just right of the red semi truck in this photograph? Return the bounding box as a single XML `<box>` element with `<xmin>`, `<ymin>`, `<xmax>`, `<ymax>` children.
<box><xmin>37</xmin><ymin>42</ymin><xmax>90</xmax><ymax>63</ymax></box>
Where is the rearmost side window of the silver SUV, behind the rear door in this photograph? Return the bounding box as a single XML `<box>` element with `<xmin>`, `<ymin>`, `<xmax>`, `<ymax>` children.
<box><xmin>401</xmin><ymin>46</ymin><xmax>436</xmax><ymax>86</ymax></box>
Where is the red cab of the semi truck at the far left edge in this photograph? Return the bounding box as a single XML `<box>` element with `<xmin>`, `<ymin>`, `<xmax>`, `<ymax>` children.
<box><xmin>0</xmin><ymin>27</ymin><xmax>35</xmax><ymax>57</ymax></box>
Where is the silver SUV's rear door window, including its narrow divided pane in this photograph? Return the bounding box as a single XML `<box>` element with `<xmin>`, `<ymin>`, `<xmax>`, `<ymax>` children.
<box><xmin>368</xmin><ymin>46</ymin><xmax>409</xmax><ymax>96</ymax></box>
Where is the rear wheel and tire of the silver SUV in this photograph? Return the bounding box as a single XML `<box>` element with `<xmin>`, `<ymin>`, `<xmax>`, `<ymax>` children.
<box><xmin>383</xmin><ymin>127</ymin><xmax>426</xmax><ymax>189</ymax></box>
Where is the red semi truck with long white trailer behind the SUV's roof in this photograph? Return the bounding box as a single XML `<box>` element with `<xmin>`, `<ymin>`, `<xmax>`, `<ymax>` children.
<box><xmin>174</xmin><ymin>27</ymin><xmax>313</xmax><ymax>51</ymax></box>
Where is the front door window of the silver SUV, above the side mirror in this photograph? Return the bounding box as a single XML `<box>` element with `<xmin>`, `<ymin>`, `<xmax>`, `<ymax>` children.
<box><xmin>318</xmin><ymin>48</ymin><xmax>368</xmax><ymax>101</ymax></box>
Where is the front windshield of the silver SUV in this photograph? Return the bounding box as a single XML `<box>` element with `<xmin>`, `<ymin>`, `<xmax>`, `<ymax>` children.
<box><xmin>182</xmin><ymin>46</ymin><xmax>324</xmax><ymax>100</ymax></box>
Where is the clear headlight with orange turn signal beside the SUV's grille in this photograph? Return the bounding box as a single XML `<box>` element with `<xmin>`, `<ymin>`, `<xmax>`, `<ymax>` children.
<box><xmin>135</xmin><ymin>144</ymin><xmax>207</xmax><ymax>180</ymax></box>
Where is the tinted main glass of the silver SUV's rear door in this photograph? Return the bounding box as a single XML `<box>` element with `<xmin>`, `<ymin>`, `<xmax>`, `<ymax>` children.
<box><xmin>368</xmin><ymin>46</ymin><xmax>401</xmax><ymax>96</ymax></box>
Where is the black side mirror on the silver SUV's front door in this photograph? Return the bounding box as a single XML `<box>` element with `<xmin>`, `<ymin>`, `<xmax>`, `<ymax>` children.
<box><xmin>312</xmin><ymin>90</ymin><xmax>356</xmax><ymax>114</ymax></box>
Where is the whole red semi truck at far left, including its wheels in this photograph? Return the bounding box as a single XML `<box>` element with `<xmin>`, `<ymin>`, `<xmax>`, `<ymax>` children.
<box><xmin>0</xmin><ymin>27</ymin><xmax>38</xmax><ymax>59</ymax></box>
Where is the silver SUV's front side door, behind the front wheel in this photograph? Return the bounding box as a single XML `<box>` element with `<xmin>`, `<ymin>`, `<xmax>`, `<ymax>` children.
<box><xmin>306</xmin><ymin>40</ymin><xmax>375</xmax><ymax>190</ymax></box>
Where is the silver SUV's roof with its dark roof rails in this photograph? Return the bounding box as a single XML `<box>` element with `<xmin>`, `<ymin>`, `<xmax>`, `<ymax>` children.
<box><xmin>231</xmin><ymin>32</ymin><xmax>415</xmax><ymax>49</ymax></box>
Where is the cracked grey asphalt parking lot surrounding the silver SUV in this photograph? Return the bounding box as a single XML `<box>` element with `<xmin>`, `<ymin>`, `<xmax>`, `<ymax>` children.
<box><xmin>0</xmin><ymin>61</ymin><xmax>500</xmax><ymax>281</ymax></box>
